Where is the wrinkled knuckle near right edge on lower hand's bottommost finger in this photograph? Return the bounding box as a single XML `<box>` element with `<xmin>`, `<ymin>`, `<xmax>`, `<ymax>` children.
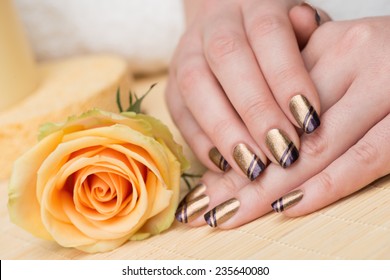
<box><xmin>350</xmin><ymin>140</ymin><xmax>379</xmax><ymax>168</ymax></box>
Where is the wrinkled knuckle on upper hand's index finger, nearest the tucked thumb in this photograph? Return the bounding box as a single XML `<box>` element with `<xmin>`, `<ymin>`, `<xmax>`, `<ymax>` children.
<box><xmin>248</xmin><ymin>14</ymin><xmax>286</xmax><ymax>38</ymax></box>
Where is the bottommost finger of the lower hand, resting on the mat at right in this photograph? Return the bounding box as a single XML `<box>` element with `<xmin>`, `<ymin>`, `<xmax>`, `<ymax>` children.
<box><xmin>274</xmin><ymin>115</ymin><xmax>390</xmax><ymax>217</ymax></box>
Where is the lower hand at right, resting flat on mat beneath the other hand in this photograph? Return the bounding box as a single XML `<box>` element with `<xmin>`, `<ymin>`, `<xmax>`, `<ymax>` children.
<box><xmin>177</xmin><ymin>17</ymin><xmax>390</xmax><ymax>228</ymax></box>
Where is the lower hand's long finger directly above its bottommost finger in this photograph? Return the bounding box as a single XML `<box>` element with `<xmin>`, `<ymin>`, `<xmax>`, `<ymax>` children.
<box><xmin>201</xmin><ymin>71</ymin><xmax>390</xmax><ymax>228</ymax></box>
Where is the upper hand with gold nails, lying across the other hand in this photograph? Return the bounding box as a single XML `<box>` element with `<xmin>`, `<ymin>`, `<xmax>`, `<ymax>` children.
<box><xmin>166</xmin><ymin>0</ymin><xmax>320</xmax><ymax>180</ymax></box>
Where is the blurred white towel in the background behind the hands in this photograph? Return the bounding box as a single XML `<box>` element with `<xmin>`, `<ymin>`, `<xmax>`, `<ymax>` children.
<box><xmin>15</xmin><ymin>0</ymin><xmax>390</xmax><ymax>72</ymax></box>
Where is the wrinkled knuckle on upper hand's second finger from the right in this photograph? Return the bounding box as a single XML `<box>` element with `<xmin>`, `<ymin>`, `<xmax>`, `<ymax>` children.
<box><xmin>206</xmin><ymin>31</ymin><xmax>242</xmax><ymax>63</ymax></box>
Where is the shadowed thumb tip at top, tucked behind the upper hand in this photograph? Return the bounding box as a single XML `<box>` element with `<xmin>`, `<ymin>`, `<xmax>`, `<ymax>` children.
<box><xmin>289</xmin><ymin>2</ymin><xmax>331</xmax><ymax>50</ymax></box>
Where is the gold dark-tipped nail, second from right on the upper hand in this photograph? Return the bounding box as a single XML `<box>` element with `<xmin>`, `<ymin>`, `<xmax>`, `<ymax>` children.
<box><xmin>266</xmin><ymin>128</ymin><xmax>299</xmax><ymax>168</ymax></box>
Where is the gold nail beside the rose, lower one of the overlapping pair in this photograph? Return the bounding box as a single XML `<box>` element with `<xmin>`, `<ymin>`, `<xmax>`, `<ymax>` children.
<box><xmin>175</xmin><ymin>195</ymin><xmax>210</xmax><ymax>224</ymax></box>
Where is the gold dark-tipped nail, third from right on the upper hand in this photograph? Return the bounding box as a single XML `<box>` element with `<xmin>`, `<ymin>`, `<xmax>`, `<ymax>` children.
<box><xmin>233</xmin><ymin>144</ymin><xmax>265</xmax><ymax>181</ymax></box>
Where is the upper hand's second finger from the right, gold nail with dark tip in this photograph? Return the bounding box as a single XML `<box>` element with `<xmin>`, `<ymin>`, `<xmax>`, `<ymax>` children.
<box><xmin>204</xmin><ymin>1</ymin><xmax>299</xmax><ymax>167</ymax></box>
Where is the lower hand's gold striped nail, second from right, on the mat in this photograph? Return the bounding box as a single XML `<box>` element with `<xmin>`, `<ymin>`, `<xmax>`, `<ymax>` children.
<box><xmin>204</xmin><ymin>198</ymin><xmax>240</xmax><ymax>227</ymax></box>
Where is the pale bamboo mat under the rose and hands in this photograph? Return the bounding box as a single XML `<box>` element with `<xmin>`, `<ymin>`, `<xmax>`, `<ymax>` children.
<box><xmin>0</xmin><ymin>77</ymin><xmax>390</xmax><ymax>260</ymax></box>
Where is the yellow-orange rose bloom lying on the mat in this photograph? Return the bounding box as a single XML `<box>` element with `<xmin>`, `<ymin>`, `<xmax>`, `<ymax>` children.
<box><xmin>8</xmin><ymin>110</ymin><xmax>188</xmax><ymax>252</ymax></box>
